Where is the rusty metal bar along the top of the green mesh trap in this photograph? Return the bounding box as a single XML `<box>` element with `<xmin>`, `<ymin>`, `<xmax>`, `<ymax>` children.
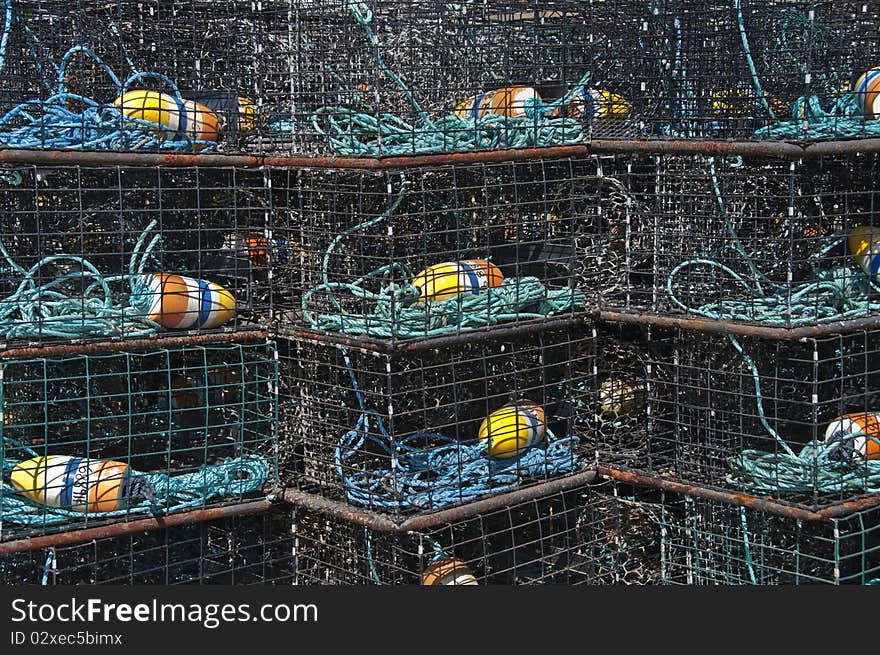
<box><xmin>0</xmin><ymin>330</ymin><xmax>269</xmax><ymax>359</ymax></box>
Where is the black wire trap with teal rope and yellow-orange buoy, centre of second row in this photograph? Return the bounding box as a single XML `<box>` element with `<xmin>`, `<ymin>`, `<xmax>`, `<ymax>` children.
<box><xmin>272</xmin><ymin>158</ymin><xmax>637</xmax><ymax>342</ymax></box>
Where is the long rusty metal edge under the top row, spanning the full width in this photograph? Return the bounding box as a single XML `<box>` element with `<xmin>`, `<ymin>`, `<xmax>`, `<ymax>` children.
<box><xmin>0</xmin><ymin>138</ymin><xmax>880</xmax><ymax>171</ymax></box>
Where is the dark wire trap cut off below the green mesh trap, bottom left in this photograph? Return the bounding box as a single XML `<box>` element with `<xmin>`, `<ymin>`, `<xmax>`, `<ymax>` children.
<box><xmin>0</xmin><ymin>509</ymin><xmax>295</xmax><ymax>586</ymax></box>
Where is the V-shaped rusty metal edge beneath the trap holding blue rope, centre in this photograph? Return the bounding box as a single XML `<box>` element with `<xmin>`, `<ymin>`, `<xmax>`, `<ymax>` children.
<box><xmin>275</xmin><ymin>469</ymin><xmax>596</xmax><ymax>532</ymax></box>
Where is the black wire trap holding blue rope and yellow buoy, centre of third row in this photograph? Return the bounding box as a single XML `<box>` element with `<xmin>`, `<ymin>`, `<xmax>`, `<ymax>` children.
<box><xmin>279</xmin><ymin>327</ymin><xmax>592</xmax><ymax>515</ymax></box>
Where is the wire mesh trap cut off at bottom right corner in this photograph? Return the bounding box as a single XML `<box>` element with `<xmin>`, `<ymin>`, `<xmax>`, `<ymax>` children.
<box><xmin>659</xmin><ymin>493</ymin><xmax>880</xmax><ymax>585</ymax></box>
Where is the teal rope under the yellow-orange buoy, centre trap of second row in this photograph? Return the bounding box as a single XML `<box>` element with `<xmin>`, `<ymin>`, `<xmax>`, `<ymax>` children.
<box><xmin>301</xmin><ymin>174</ymin><xmax>586</xmax><ymax>339</ymax></box>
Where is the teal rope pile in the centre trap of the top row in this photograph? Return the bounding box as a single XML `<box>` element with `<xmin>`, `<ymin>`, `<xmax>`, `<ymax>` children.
<box><xmin>292</xmin><ymin>0</ymin><xmax>590</xmax><ymax>156</ymax></box>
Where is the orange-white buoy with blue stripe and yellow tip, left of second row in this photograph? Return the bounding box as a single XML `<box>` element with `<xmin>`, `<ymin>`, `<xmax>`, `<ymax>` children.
<box><xmin>145</xmin><ymin>273</ymin><xmax>235</xmax><ymax>330</ymax></box>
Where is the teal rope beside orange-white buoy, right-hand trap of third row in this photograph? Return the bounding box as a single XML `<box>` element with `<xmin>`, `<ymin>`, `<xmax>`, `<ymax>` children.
<box><xmin>727</xmin><ymin>335</ymin><xmax>880</xmax><ymax>493</ymax></box>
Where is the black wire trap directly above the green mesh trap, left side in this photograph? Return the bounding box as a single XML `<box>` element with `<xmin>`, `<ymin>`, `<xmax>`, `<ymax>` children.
<box><xmin>0</xmin><ymin>166</ymin><xmax>272</xmax><ymax>343</ymax></box>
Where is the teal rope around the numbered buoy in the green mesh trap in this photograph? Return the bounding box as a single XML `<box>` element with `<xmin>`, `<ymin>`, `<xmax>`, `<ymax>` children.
<box><xmin>0</xmin><ymin>437</ymin><xmax>269</xmax><ymax>525</ymax></box>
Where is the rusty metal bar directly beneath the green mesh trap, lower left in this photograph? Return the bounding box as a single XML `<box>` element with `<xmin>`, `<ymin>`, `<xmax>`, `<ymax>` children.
<box><xmin>0</xmin><ymin>499</ymin><xmax>272</xmax><ymax>555</ymax></box>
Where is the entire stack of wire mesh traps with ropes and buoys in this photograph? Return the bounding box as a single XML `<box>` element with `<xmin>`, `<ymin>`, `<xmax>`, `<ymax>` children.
<box><xmin>0</xmin><ymin>0</ymin><xmax>880</xmax><ymax>585</ymax></box>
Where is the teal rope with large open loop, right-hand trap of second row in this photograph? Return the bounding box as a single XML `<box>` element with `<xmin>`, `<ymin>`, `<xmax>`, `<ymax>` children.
<box><xmin>666</xmin><ymin>158</ymin><xmax>880</xmax><ymax>325</ymax></box>
